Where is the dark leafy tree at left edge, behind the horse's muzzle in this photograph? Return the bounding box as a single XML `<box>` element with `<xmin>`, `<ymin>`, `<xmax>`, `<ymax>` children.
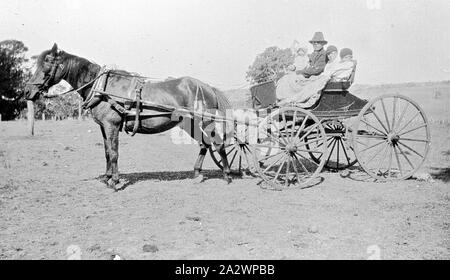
<box><xmin>0</xmin><ymin>40</ymin><xmax>30</xmax><ymax>120</ymax></box>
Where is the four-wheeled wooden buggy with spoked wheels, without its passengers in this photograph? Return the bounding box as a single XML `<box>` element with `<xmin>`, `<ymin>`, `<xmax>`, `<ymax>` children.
<box><xmin>211</xmin><ymin>71</ymin><xmax>430</xmax><ymax>189</ymax></box>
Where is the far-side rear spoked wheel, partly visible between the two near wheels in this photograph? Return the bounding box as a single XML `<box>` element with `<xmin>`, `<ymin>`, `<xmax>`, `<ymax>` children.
<box><xmin>305</xmin><ymin>120</ymin><xmax>356</xmax><ymax>170</ymax></box>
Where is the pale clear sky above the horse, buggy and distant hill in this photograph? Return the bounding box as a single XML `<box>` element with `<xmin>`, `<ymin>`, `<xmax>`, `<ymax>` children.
<box><xmin>0</xmin><ymin>0</ymin><xmax>450</xmax><ymax>89</ymax></box>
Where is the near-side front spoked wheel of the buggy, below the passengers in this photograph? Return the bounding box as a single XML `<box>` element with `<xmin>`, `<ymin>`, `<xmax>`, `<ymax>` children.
<box><xmin>252</xmin><ymin>107</ymin><xmax>327</xmax><ymax>190</ymax></box>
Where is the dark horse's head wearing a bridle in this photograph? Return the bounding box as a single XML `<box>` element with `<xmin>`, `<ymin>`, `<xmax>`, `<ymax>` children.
<box><xmin>25</xmin><ymin>43</ymin><xmax>66</xmax><ymax>100</ymax></box>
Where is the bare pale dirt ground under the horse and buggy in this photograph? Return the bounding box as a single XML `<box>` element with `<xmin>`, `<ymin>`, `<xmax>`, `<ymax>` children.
<box><xmin>0</xmin><ymin>95</ymin><xmax>450</xmax><ymax>259</ymax></box>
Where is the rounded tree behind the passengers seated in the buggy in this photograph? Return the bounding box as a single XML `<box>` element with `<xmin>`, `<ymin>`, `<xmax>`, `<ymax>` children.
<box><xmin>246</xmin><ymin>46</ymin><xmax>294</xmax><ymax>83</ymax></box>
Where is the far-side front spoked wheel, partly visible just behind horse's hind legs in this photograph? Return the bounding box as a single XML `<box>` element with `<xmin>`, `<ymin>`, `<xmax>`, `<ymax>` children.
<box><xmin>209</xmin><ymin>139</ymin><xmax>255</xmax><ymax>175</ymax></box>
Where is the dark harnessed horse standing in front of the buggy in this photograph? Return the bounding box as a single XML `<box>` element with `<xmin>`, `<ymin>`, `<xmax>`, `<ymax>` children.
<box><xmin>24</xmin><ymin>43</ymin><xmax>231</xmax><ymax>191</ymax></box>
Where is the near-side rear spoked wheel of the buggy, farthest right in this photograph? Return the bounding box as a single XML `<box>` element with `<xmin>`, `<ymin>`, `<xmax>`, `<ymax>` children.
<box><xmin>352</xmin><ymin>94</ymin><xmax>431</xmax><ymax>181</ymax></box>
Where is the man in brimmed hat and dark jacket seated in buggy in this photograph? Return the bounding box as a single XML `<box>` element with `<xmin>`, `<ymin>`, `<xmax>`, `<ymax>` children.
<box><xmin>296</xmin><ymin>32</ymin><xmax>328</xmax><ymax>78</ymax></box>
